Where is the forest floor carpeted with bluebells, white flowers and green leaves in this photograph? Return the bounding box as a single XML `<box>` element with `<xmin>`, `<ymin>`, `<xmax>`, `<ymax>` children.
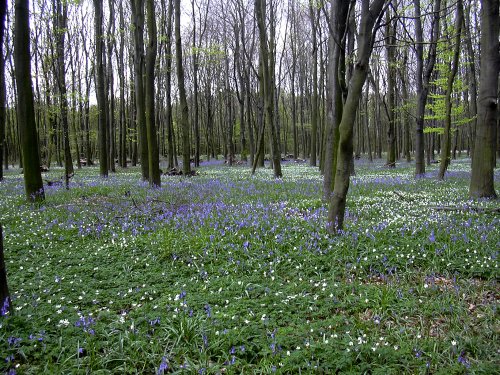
<box><xmin>0</xmin><ymin>160</ymin><xmax>500</xmax><ymax>374</ymax></box>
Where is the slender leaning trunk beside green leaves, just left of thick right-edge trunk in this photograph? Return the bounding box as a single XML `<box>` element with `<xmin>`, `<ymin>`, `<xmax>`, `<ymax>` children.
<box><xmin>438</xmin><ymin>0</ymin><xmax>464</xmax><ymax>180</ymax></box>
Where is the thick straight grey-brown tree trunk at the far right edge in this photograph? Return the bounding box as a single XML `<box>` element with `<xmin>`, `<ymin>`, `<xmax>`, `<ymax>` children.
<box><xmin>469</xmin><ymin>0</ymin><xmax>500</xmax><ymax>198</ymax></box>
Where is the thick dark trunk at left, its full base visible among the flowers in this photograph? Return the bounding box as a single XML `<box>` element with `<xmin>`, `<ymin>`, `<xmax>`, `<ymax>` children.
<box><xmin>14</xmin><ymin>0</ymin><xmax>45</xmax><ymax>202</ymax></box>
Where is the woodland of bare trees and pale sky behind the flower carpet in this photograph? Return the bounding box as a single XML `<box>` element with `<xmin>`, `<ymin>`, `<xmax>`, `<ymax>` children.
<box><xmin>0</xmin><ymin>0</ymin><xmax>500</xmax><ymax>227</ymax></box>
